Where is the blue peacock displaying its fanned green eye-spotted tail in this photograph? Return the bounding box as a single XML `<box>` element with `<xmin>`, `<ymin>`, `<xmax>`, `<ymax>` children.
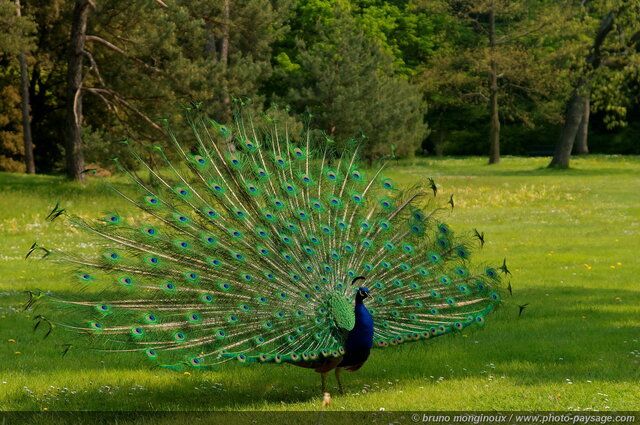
<box><xmin>27</xmin><ymin>105</ymin><xmax>508</xmax><ymax>393</ymax></box>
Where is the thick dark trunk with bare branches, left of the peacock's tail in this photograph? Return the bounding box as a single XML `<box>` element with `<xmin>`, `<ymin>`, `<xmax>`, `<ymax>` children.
<box><xmin>65</xmin><ymin>0</ymin><xmax>91</xmax><ymax>181</ymax></box>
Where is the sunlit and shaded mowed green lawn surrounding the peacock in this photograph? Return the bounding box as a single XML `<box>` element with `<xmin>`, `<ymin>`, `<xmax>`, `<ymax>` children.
<box><xmin>0</xmin><ymin>156</ymin><xmax>640</xmax><ymax>411</ymax></box>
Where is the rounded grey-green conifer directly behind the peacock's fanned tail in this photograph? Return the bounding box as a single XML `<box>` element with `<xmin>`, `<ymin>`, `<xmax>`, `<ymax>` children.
<box><xmin>286</xmin><ymin>11</ymin><xmax>426</xmax><ymax>159</ymax></box>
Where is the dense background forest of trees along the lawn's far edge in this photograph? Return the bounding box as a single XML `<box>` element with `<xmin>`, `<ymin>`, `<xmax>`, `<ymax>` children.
<box><xmin>0</xmin><ymin>0</ymin><xmax>640</xmax><ymax>179</ymax></box>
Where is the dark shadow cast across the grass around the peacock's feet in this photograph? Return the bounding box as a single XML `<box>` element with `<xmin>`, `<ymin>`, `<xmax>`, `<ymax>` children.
<box><xmin>0</xmin><ymin>287</ymin><xmax>640</xmax><ymax>410</ymax></box>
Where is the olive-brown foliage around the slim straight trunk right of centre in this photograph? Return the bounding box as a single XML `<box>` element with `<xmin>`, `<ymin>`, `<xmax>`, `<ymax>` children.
<box><xmin>417</xmin><ymin>0</ymin><xmax>575</xmax><ymax>154</ymax></box>
